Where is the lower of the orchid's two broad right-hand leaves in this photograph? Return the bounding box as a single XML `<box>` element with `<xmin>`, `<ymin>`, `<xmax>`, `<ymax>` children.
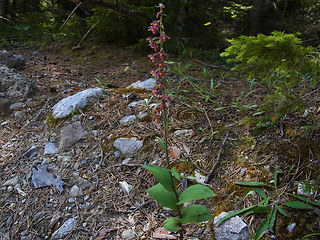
<box><xmin>181</xmin><ymin>204</ymin><xmax>212</xmax><ymax>224</ymax></box>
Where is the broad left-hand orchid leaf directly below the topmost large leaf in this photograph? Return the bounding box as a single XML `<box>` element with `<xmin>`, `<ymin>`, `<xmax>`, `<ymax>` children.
<box><xmin>146</xmin><ymin>183</ymin><xmax>178</xmax><ymax>211</ymax></box>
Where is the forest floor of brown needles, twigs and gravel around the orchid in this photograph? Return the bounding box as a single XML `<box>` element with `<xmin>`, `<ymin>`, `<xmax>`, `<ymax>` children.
<box><xmin>0</xmin><ymin>45</ymin><xmax>320</xmax><ymax>240</ymax></box>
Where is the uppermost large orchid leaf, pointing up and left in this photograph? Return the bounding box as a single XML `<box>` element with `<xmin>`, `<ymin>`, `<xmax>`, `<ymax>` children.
<box><xmin>143</xmin><ymin>165</ymin><xmax>176</xmax><ymax>192</ymax></box>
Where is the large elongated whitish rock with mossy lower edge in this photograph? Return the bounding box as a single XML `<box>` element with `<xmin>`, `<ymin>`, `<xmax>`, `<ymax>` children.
<box><xmin>52</xmin><ymin>88</ymin><xmax>106</xmax><ymax>118</ymax></box>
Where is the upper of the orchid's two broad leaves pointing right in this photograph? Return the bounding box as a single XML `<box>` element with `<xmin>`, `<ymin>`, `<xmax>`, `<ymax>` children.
<box><xmin>177</xmin><ymin>184</ymin><xmax>216</xmax><ymax>205</ymax></box>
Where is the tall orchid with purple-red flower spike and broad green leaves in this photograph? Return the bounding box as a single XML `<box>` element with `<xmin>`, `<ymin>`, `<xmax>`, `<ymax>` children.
<box><xmin>144</xmin><ymin>3</ymin><xmax>216</xmax><ymax>240</ymax></box>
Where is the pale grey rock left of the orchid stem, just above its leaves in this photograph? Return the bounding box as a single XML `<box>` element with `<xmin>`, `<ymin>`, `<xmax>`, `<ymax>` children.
<box><xmin>113</xmin><ymin>137</ymin><xmax>143</xmax><ymax>155</ymax></box>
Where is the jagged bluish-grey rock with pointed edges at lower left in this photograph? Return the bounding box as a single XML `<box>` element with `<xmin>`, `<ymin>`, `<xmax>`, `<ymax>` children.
<box><xmin>31</xmin><ymin>164</ymin><xmax>66</xmax><ymax>193</ymax></box>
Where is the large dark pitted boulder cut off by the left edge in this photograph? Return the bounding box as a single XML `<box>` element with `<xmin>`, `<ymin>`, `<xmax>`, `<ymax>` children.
<box><xmin>0</xmin><ymin>64</ymin><xmax>39</xmax><ymax>99</ymax></box>
